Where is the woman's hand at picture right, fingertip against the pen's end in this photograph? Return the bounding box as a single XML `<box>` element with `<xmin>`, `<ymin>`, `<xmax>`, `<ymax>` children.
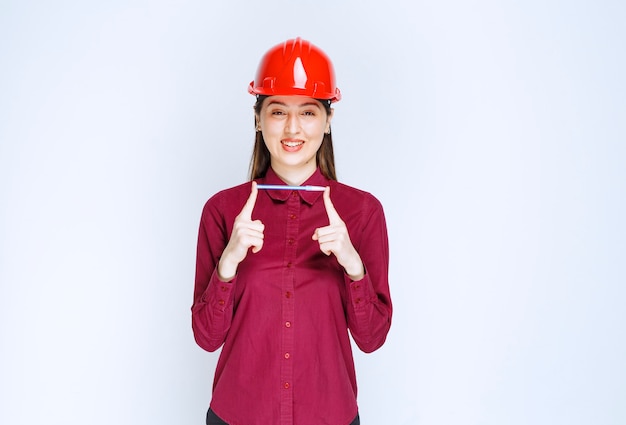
<box><xmin>313</xmin><ymin>187</ymin><xmax>365</xmax><ymax>280</ymax></box>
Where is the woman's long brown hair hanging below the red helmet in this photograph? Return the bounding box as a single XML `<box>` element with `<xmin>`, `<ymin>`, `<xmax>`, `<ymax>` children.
<box><xmin>250</xmin><ymin>96</ymin><xmax>337</xmax><ymax>180</ymax></box>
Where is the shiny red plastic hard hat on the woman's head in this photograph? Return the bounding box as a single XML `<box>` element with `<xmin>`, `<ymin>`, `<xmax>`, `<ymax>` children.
<box><xmin>248</xmin><ymin>37</ymin><xmax>341</xmax><ymax>102</ymax></box>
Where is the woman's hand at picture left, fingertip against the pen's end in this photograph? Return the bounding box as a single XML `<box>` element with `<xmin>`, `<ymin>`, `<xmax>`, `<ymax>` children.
<box><xmin>217</xmin><ymin>182</ymin><xmax>265</xmax><ymax>282</ymax></box>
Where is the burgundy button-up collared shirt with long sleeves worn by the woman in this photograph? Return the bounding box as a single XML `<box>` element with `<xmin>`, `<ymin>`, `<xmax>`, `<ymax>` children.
<box><xmin>192</xmin><ymin>168</ymin><xmax>392</xmax><ymax>425</ymax></box>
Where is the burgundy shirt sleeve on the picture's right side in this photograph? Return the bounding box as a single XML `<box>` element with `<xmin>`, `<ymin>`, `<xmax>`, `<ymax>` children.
<box><xmin>345</xmin><ymin>192</ymin><xmax>392</xmax><ymax>353</ymax></box>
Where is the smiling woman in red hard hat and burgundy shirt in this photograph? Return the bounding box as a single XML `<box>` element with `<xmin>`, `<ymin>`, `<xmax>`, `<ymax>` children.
<box><xmin>192</xmin><ymin>38</ymin><xmax>392</xmax><ymax>425</ymax></box>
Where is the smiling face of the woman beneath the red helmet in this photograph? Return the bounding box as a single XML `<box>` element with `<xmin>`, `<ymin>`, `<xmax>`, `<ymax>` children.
<box><xmin>256</xmin><ymin>96</ymin><xmax>332</xmax><ymax>177</ymax></box>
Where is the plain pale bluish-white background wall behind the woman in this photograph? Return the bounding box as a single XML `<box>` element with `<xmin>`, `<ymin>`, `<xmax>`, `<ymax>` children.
<box><xmin>0</xmin><ymin>0</ymin><xmax>626</xmax><ymax>425</ymax></box>
